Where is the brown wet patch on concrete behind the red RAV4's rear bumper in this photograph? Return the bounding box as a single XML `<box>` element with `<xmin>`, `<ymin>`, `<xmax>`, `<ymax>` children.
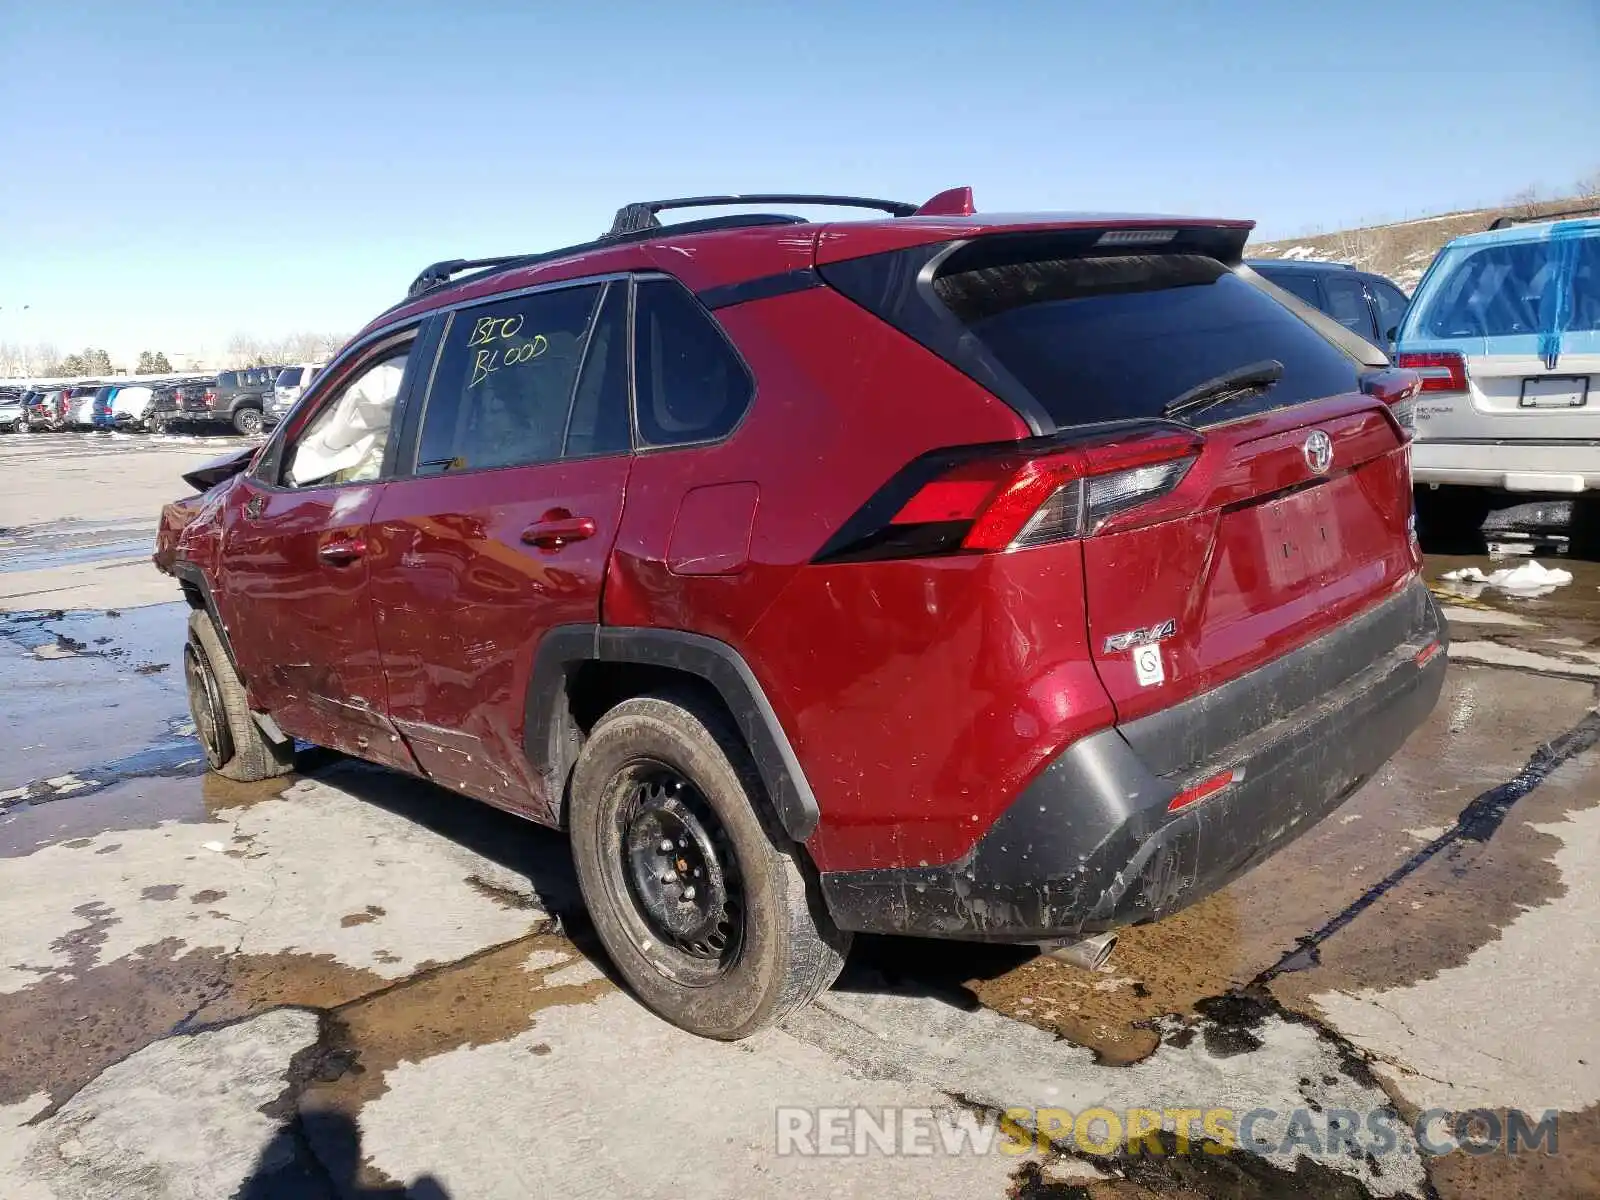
<box><xmin>966</xmin><ymin>669</ymin><xmax>1595</xmax><ymax>1066</ymax></box>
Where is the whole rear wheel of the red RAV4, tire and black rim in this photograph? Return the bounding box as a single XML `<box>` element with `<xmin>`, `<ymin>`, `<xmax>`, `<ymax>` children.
<box><xmin>570</xmin><ymin>693</ymin><xmax>850</xmax><ymax>1042</ymax></box>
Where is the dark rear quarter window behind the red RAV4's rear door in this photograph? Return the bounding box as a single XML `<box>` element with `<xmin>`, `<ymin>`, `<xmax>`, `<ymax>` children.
<box><xmin>634</xmin><ymin>280</ymin><xmax>754</xmax><ymax>446</ymax></box>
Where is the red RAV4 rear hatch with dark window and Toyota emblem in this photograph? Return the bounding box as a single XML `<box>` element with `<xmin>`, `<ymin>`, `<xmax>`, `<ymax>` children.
<box><xmin>824</xmin><ymin>229</ymin><xmax>1418</xmax><ymax>720</ymax></box>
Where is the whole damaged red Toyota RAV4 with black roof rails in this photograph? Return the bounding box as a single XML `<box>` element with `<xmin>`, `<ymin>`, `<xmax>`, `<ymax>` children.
<box><xmin>157</xmin><ymin>189</ymin><xmax>1445</xmax><ymax>1038</ymax></box>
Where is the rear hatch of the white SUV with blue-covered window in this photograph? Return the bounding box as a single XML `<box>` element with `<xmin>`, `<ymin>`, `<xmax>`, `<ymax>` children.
<box><xmin>1400</xmin><ymin>221</ymin><xmax>1600</xmax><ymax>442</ymax></box>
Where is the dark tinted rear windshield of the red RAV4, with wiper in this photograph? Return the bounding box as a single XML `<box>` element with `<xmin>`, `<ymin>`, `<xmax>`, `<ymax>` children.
<box><xmin>933</xmin><ymin>254</ymin><xmax>1357</xmax><ymax>426</ymax></box>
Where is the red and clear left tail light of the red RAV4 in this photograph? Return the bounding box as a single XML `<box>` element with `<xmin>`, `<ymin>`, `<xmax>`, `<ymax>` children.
<box><xmin>816</xmin><ymin>427</ymin><xmax>1205</xmax><ymax>562</ymax></box>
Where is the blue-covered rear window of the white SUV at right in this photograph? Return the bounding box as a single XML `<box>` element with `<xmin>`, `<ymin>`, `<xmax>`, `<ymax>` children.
<box><xmin>1408</xmin><ymin>237</ymin><xmax>1600</xmax><ymax>338</ymax></box>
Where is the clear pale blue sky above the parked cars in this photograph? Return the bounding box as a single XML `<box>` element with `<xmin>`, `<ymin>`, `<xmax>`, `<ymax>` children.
<box><xmin>0</xmin><ymin>0</ymin><xmax>1600</xmax><ymax>355</ymax></box>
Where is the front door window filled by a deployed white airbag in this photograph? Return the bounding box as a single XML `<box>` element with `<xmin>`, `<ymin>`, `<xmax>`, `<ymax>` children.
<box><xmin>283</xmin><ymin>347</ymin><xmax>410</xmax><ymax>488</ymax></box>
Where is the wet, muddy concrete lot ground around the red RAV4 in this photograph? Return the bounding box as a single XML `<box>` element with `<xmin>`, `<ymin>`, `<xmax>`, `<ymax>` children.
<box><xmin>0</xmin><ymin>435</ymin><xmax>1600</xmax><ymax>1200</ymax></box>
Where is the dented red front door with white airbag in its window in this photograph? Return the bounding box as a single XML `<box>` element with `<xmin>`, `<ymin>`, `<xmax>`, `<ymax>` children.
<box><xmin>218</xmin><ymin>336</ymin><xmax>414</xmax><ymax>770</ymax></box>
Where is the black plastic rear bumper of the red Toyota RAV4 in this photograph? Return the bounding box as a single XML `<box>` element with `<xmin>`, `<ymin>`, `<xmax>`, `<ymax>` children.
<box><xmin>822</xmin><ymin>582</ymin><xmax>1446</xmax><ymax>942</ymax></box>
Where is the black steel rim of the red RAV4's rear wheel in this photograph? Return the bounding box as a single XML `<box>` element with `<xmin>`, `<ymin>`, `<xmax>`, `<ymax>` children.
<box><xmin>613</xmin><ymin>763</ymin><xmax>744</xmax><ymax>987</ymax></box>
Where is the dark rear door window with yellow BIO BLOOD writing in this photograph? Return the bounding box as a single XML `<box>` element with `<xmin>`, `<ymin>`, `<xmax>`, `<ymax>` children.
<box><xmin>416</xmin><ymin>285</ymin><xmax>603</xmax><ymax>475</ymax></box>
